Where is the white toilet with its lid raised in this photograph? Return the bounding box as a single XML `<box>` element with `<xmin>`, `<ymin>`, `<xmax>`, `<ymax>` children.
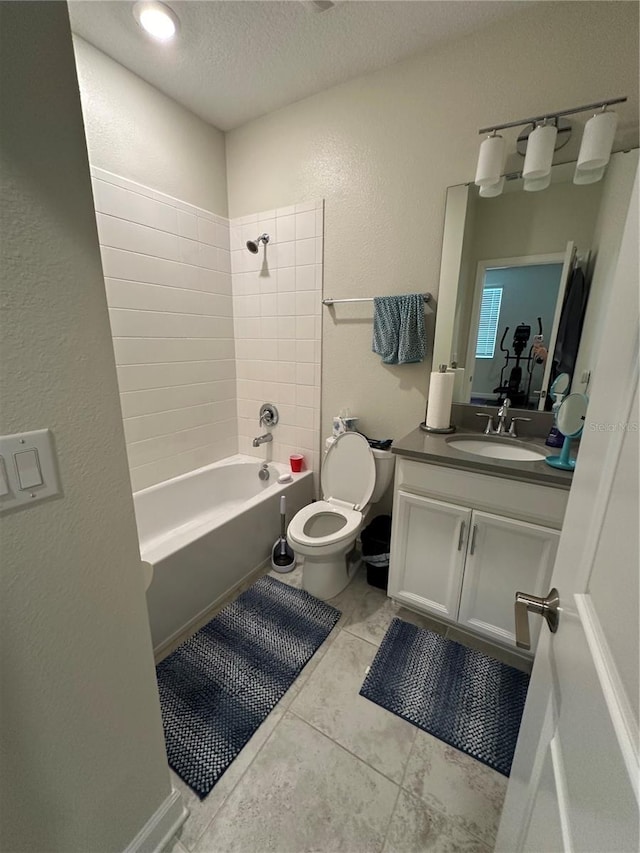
<box><xmin>287</xmin><ymin>432</ymin><xmax>394</xmax><ymax>600</ymax></box>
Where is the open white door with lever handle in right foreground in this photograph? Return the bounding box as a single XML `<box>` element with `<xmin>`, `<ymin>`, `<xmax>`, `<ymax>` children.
<box><xmin>496</xmin><ymin>170</ymin><xmax>640</xmax><ymax>853</ymax></box>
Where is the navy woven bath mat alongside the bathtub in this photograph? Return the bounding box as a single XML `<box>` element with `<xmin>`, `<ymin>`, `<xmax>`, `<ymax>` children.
<box><xmin>156</xmin><ymin>577</ymin><xmax>340</xmax><ymax>799</ymax></box>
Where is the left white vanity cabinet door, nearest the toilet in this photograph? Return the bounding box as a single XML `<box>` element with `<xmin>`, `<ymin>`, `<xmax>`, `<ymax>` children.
<box><xmin>389</xmin><ymin>489</ymin><xmax>471</xmax><ymax>620</ymax></box>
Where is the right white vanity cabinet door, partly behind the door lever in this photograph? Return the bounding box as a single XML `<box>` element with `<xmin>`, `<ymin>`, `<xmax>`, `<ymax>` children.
<box><xmin>458</xmin><ymin>510</ymin><xmax>560</xmax><ymax>652</ymax></box>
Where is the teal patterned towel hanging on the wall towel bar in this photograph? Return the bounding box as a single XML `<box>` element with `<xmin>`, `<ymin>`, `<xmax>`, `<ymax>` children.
<box><xmin>372</xmin><ymin>293</ymin><xmax>425</xmax><ymax>364</ymax></box>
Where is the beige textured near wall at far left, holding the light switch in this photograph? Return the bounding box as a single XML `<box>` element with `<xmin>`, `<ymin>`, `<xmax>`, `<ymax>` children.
<box><xmin>0</xmin><ymin>2</ymin><xmax>170</xmax><ymax>853</ymax></box>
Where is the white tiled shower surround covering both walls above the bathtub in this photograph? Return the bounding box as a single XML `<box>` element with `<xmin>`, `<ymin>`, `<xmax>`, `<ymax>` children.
<box><xmin>91</xmin><ymin>167</ymin><xmax>322</xmax><ymax>491</ymax></box>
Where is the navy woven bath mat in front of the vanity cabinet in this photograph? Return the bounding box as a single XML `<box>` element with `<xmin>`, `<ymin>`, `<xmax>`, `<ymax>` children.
<box><xmin>360</xmin><ymin>619</ymin><xmax>529</xmax><ymax>776</ymax></box>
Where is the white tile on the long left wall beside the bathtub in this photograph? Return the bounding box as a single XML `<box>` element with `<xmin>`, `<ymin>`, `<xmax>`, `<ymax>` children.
<box><xmin>94</xmin><ymin>172</ymin><xmax>242</xmax><ymax>489</ymax></box>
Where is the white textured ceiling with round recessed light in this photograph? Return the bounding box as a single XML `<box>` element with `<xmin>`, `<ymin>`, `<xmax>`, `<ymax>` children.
<box><xmin>69</xmin><ymin>0</ymin><xmax>530</xmax><ymax>130</ymax></box>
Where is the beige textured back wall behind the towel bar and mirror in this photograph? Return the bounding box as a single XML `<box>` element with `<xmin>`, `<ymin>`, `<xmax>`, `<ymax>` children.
<box><xmin>227</xmin><ymin>2</ymin><xmax>638</xmax><ymax>446</ymax></box>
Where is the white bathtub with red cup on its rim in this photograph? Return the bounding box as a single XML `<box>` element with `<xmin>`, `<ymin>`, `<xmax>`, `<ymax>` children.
<box><xmin>133</xmin><ymin>455</ymin><xmax>313</xmax><ymax>657</ymax></box>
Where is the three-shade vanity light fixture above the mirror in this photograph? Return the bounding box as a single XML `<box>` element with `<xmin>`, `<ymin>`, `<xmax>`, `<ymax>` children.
<box><xmin>475</xmin><ymin>97</ymin><xmax>627</xmax><ymax>198</ymax></box>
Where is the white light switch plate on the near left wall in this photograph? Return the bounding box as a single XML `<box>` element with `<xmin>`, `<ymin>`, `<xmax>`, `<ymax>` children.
<box><xmin>0</xmin><ymin>429</ymin><xmax>60</xmax><ymax>512</ymax></box>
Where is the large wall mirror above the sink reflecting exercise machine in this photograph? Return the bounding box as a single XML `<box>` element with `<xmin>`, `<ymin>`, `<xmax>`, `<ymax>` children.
<box><xmin>433</xmin><ymin>149</ymin><xmax>638</xmax><ymax>410</ymax></box>
